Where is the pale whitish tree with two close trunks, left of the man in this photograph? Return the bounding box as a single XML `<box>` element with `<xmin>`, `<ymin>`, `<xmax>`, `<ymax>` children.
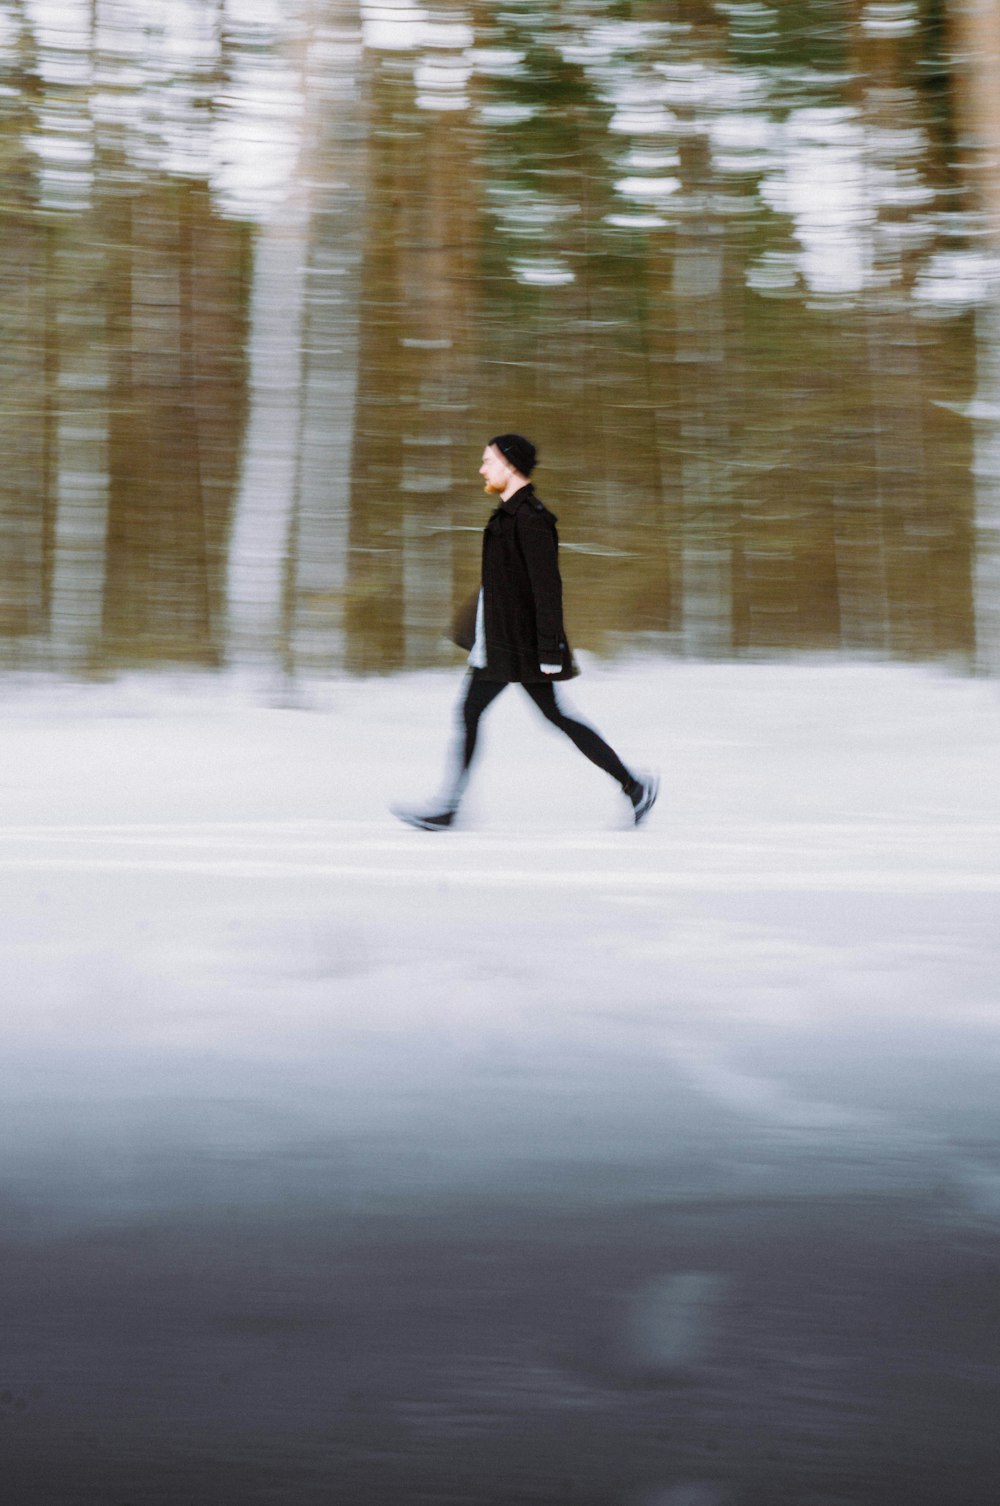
<box><xmin>227</xmin><ymin>0</ymin><xmax>361</xmax><ymax>683</ymax></box>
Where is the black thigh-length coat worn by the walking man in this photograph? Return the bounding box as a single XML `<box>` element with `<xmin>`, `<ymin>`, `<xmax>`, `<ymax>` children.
<box><xmin>476</xmin><ymin>483</ymin><xmax>578</xmax><ymax>685</ymax></box>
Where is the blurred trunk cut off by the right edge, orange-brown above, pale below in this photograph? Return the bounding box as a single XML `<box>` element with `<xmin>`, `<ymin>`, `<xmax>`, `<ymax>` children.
<box><xmin>952</xmin><ymin>0</ymin><xmax>1000</xmax><ymax>675</ymax></box>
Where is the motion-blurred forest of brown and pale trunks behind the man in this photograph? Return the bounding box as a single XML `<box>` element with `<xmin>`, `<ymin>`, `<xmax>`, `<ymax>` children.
<box><xmin>0</xmin><ymin>0</ymin><xmax>1000</xmax><ymax>675</ymax></box>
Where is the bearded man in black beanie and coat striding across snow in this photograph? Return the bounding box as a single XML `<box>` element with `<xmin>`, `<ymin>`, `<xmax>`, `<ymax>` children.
<box><xmin>395</xmin><ymin>434</ymin><xmax>658</xmax><ymax>831</ymax></box>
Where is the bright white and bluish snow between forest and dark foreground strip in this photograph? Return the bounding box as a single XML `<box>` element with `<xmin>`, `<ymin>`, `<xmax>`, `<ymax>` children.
<box><xmin>0</xmin><ymin>657</ymin><xmax>1000</xmax><ymax>1217</ymax></box>
